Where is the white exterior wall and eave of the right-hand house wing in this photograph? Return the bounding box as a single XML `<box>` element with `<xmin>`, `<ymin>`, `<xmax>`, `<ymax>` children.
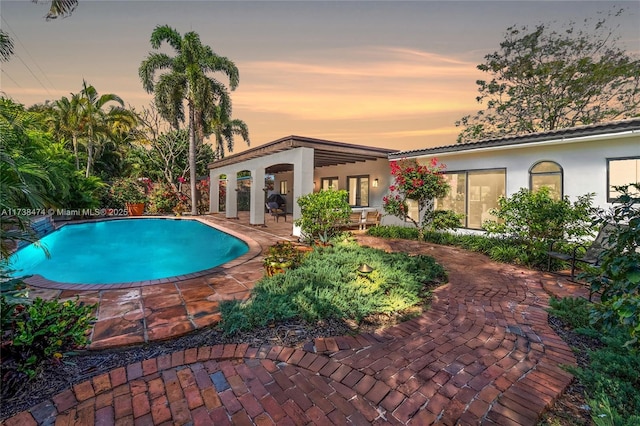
<box><xmin>400</xmin><ymin>133</ymin><xmax>640</xmax><ymax>230</ymax></box>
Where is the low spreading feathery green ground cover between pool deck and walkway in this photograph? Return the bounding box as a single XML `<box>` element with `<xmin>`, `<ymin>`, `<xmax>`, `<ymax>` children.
<box><xmin>220</xmin><ymin>240</ymin><xmax>446</xmax><ymax>334</ymax></box>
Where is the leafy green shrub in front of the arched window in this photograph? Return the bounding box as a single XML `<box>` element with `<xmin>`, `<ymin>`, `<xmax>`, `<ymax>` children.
<box><xmin>483</xmin><ymin>187</ymin><xmax>594</xmax><ymax>263</ymax></box>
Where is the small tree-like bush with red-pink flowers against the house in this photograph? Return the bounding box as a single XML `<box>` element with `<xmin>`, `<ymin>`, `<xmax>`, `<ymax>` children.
<box><xmin>382</xmin><ymin>158</ymin><xmax>460</xmax><ymax>238</ymax></box>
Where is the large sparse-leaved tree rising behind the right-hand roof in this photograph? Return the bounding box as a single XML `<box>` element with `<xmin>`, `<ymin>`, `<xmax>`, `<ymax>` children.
<box><xmin>456</xmin><ymin>10</ymin><xmax>640</xmax><ymax>142</ymax></box>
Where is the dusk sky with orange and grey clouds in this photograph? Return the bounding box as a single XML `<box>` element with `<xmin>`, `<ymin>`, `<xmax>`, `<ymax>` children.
<box><xmin>0</xmin><ymin>0</ymin><xmax>640</xmax><ymax>152</ymax></box>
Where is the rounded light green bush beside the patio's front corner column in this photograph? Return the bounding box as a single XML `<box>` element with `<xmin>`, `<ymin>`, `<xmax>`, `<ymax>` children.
<box><xmin>294</xmin><ymin>189</ymin><xmax>351</xmax><ymax>242</ymax></box>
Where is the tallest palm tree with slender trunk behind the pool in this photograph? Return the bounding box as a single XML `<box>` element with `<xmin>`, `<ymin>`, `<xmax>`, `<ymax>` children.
<box><xmin>138</xmin><ymin>25</ymin><xmax>239</xmax><ymax>215</ymax></box>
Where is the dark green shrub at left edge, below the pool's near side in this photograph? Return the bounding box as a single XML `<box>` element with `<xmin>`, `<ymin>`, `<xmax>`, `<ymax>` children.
<box><xmin>0</xmin><ymin>296</ymin><xmax>96</xmax><ymax>378</ymax></box>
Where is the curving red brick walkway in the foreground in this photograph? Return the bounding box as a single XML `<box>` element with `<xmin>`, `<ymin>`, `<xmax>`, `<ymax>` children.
<box><xmin>5</xmin><ymin>236</ymin><xmax>575</xmax><ymax>426</ymax></box>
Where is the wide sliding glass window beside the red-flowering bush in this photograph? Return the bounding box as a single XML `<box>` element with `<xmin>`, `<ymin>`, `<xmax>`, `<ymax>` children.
<box><xmin>436</xmin><ymin>169</ymin><xmax>507</xmax><ymax>229</ymax></box>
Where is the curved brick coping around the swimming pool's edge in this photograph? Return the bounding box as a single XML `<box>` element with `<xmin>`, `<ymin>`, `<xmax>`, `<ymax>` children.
<box><xmin>23</xmin><ymin>216</ymin><xmax>262</xmax><ymax>291</ymax></box>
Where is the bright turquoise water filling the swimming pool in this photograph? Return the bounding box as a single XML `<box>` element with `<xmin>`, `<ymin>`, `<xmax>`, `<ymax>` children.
<box><xmin>9</xmin><ymin>219</ymin><xmax>249</xmax><ymax>284</ymax></box>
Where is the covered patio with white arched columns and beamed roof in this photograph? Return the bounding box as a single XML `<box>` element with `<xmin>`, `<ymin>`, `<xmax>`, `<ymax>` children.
<box><xmin>209</xmin><ymin>136</ymin><xmax>395</xmax><ymax>236</ymax></box>
